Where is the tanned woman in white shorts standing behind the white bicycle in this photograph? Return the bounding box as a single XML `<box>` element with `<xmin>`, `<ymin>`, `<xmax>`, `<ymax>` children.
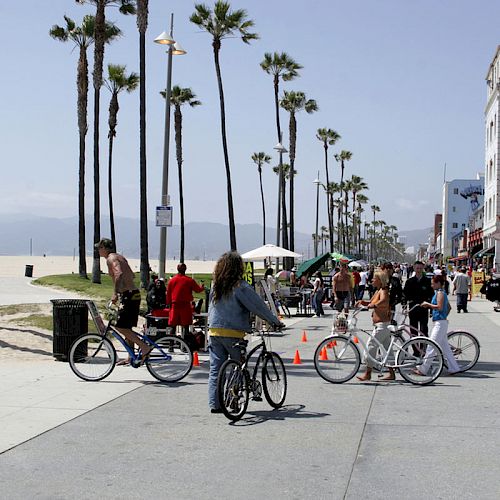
<box><xmin>356</xmin><ymin>271</ymin><xmax>396</xmax><ymax>382</ymax></box>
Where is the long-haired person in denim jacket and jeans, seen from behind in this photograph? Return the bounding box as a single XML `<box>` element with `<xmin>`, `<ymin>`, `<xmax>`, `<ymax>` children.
<box><xmin>208</xmin><ymin>252</ymin><xmax>283</xmax><ymax>413</ymax></box>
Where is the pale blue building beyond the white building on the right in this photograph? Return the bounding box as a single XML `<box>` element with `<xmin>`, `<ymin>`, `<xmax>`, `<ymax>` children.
<box><xmin>444</xmin><ymin>174</ymin><xmax>484</xmax><ymax>259</ymax></box>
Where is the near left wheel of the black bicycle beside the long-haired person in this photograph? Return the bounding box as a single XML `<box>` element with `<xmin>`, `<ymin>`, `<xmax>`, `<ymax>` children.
<box><xmin>217</xmin><ymin>359</ymin><xmax>250</xmax><ymax>422</ymax></box>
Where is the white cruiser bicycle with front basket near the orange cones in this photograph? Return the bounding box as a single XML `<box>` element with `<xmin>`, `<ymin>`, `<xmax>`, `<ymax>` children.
<box><xmin>314</xmin><ymin>308</ymin><xmax>444</xmax><ymax>385</ymax></box>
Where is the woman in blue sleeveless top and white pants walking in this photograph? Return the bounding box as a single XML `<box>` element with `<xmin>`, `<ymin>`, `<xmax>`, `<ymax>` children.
<box><xmin>415</xmin><ymin>274</ymin><xmax>460</xmax><ymax>375</ymax></box>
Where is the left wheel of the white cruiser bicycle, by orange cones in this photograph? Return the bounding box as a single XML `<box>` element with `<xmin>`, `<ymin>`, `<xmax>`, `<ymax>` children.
<box><xmin>314</xmin><ymin>335</ymin><xmax>361</xmax><ymax>384</ymax></box>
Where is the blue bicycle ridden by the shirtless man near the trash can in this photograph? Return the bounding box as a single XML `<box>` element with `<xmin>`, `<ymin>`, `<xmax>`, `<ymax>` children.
<box><xmin>69</xmin><ymin>301</ymin><xmax>193</xmax><ymax>382</ymax></box>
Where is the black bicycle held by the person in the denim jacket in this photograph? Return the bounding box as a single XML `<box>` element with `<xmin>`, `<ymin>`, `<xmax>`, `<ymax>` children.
<box><xmin>217</xmin><ymin>330</ymin><xmax>287</xmax><ymax>422</ymax></box>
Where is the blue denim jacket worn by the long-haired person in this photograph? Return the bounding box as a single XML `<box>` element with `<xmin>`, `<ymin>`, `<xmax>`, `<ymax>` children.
<box><xmin>208</xmin><ymin>280</ymin><xmax>280</xmax><ymax>332</ymax></box>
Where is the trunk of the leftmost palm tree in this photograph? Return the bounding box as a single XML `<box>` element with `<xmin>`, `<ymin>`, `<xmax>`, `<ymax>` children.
<box><xmin>77</xmin><ymin>47</ymin><xmax>89</xmax><ymax>279</ymax></box>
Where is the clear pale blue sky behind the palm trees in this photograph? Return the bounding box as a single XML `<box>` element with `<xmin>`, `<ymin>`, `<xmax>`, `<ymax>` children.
<box><xmin>0</xmin><ymin>0</ymin><xmax>500</xmax><ymax>238</ymax></box>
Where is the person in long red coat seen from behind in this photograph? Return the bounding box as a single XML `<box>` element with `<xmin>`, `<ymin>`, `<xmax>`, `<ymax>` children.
<box><xmin>167</xmin><ymin>263</ymin><xmax>204</xmax><ymax>334</ymax></box>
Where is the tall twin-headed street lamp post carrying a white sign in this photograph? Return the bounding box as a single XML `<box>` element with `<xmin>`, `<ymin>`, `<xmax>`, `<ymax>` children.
<box><xmin>154</xmin><ymin>14</ymin><xmax>186</xmax><ymax>278</ymax></box>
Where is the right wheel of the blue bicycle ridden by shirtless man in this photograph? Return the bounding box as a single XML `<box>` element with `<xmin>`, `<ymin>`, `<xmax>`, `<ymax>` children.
<box><xmin>145</xmin><ymin>335</ymin><xmax>193</xmax><ymax>382</ymax></box>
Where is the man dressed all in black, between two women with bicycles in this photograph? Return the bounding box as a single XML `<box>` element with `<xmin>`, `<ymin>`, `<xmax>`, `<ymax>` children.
<box><xmin>403</xmin><ymin>260</ymin><xmax>433</xmax><ymax>335</ymax></box>
